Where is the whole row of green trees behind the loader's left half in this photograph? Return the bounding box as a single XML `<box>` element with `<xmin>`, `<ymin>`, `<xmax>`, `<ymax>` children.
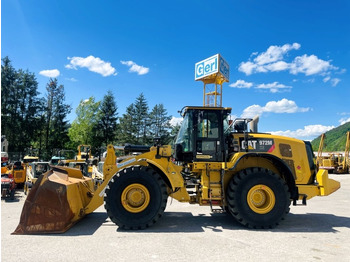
<box><xmin>1</xmin><ymin>56</ymin><xmax>179</xmax><ymax>160</ymax></box>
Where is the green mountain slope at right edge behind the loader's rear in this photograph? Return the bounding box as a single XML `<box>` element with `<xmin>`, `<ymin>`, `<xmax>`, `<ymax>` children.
<box><xmin>311</xmin><ymin>122</ymin><xmax>350</xmax><ymax>152</ymax></box>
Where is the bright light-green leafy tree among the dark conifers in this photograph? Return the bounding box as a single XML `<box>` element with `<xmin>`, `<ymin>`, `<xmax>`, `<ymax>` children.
<box><xmin>68</xmin><ymin>97</ymin><xmax>100</xmax><ymax>147</ymax></box>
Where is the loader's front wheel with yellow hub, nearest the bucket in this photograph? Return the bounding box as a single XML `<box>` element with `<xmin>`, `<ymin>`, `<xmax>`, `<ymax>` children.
<box><xmin>104</xmin><ymin>166</ymin><xmax>168</xmax><ymax>229</ymax></box>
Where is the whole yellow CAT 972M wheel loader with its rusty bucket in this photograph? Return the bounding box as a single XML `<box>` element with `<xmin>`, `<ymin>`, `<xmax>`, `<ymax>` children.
<box><xmin>14</xmin><ymin>107</ymin><xmax>340</xmax><ymax>234</ymax></box>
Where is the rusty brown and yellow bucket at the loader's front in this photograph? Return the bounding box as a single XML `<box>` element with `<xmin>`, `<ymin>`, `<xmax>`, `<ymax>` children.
<box><xmin>12</xmin><ymin>167</ymin><xmax>97</xmax><ymax>234</ymax></box>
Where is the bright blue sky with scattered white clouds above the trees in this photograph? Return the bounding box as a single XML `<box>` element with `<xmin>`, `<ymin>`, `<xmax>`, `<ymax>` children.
<box><xmin>1</xmin><ymin>0</ymin><xmax>350</xmax><ymax>140</ymax></box>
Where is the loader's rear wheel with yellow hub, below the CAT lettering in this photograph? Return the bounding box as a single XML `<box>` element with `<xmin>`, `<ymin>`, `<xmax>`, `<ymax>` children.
<box><xmin>227</xmin><ymin>167</ymin><xmax>291</xmax><ymax>228</ymax></box>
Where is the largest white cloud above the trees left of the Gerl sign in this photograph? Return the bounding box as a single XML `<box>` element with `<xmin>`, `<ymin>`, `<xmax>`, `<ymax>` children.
<box><xmin>66</xmin><ymin>55</ymin><xmax>118</xmax><ymax>76</ymax></box>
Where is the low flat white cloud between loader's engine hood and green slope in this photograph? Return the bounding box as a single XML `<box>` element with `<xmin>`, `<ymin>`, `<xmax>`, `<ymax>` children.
<box><xmin>269</xmin><ymin>125</ymin><xmax>334</xmax><ymax>140</ymax></box>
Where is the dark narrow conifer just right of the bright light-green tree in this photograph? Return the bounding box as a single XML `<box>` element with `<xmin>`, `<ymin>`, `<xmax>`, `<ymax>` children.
<box><xmin>95</xmin><ymin>91</ymin><xmax>118</xmax><ymax>146</ymax></box>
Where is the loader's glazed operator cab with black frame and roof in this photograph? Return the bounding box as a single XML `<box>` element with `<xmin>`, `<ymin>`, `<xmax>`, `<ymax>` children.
<box><xmin>175</xmin><ymin>107</ymin><xmax>231</xmax><ymax>162</ymax></box>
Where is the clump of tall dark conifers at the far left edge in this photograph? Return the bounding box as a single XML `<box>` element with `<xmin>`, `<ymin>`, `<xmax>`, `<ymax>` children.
<box><xmin>1</xmin><ymin>57</ymin><xmax>42</xmax><ymax>153</ymax></box>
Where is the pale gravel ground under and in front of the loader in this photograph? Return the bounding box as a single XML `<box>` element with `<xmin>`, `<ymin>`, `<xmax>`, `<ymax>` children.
<box><xmin>1</xmin><ymin>175</ymin><xmax>350</xmax><ymax>262</ymax></box>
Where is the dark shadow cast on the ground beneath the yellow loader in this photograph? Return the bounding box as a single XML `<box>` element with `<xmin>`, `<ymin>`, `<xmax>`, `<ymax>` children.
<box><xmin>63</xmin><ymin>209</ymin><xmax>350</xmax><ymax>236</ymax></box>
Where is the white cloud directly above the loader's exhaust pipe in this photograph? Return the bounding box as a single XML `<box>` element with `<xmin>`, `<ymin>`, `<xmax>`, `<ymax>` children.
<box><xmin>241</xmin><ymin>98</ymin><xmax>310</xmax><ymax>118</ymax></box>
